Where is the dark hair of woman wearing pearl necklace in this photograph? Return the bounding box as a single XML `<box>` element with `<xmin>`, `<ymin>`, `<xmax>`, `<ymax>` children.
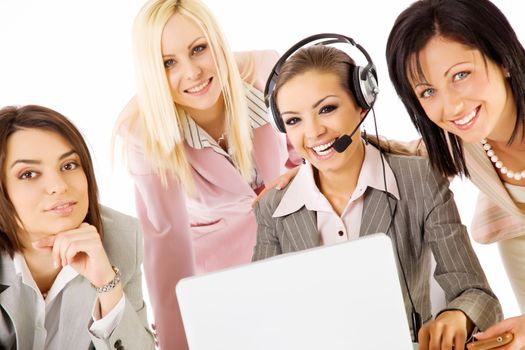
<box><xmin>386</xmin><ymin>0</ymin><xmax>525</xmax><ymax>176</ymax></box>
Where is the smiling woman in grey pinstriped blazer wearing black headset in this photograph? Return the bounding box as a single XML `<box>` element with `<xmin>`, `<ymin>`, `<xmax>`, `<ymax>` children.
<box><xmin>253</xmin><ymin>35</ymin><xmax>501</xmax><ymax>349</ymax></box>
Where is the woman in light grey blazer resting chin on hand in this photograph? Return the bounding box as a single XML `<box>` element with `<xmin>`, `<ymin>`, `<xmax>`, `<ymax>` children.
<box><xmin>0</xmin><ymin>106</ymin><xmax>154</xmax><ymax>350</ymax></box>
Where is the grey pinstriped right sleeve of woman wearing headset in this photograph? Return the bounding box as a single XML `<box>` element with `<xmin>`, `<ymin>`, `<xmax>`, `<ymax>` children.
<box><xmin>424</xmin><ymin>163</ymin><xmax>502</xmax><ymax>330</ymax></box>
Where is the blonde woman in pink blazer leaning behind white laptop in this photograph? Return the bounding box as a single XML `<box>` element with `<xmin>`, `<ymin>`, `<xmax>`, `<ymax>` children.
<box><xmin>117</xmin><ymin>0</ymin><xmax>294</xmax><ymax>349</ymax></box>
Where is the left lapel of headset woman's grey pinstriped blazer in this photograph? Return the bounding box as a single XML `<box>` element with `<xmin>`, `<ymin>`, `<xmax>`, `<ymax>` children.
<box><xmin>283</xmin><ymin>207</ymin><xmax>321</xmax><ymax>253</ymax></box>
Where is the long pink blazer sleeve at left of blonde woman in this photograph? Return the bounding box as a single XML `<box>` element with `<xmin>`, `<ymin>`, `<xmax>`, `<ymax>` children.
<box><xmin>128</xmin><ymin>136</ymin><xmax>195</xmax><ymax>349</ymax></box>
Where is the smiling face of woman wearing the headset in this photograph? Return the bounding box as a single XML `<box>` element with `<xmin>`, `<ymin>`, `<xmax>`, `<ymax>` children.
<box><xmin>276</xmin><ymin>70</ymin><xmax>365</xmax><ymax>172</ymax></box>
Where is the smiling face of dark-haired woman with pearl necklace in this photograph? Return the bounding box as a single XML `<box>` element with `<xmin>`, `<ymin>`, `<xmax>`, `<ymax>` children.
<box><xmin>409</xmin><ymin>36</ymin><xmax>516</xmax><ymax>143</ymax></box>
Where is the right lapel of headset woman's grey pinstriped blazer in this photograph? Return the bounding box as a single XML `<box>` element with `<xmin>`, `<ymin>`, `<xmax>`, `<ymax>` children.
<box><xmin>359</xmin><ymin>187</ymin><xmax>397</xmax><ymax>237</ymax></box>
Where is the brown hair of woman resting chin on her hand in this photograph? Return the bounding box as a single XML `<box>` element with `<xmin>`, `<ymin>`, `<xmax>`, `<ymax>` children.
<box><xmin>0</xmin><ymin>105</ymin><xmax>103</xmax><ymax>257</ymax></box>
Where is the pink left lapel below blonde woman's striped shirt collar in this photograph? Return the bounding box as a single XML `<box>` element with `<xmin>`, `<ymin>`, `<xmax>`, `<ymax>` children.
<box><xmin>185</xmin><ymin>144</ymin><xmax>254</xmax><ymax>196</ymax></box>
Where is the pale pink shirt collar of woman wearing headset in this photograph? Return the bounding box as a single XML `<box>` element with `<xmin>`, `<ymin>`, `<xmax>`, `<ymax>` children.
<box><xmin>272</xmin><ymin>144</ymin><xmax>400</xmax><ymax>217</ymax></box>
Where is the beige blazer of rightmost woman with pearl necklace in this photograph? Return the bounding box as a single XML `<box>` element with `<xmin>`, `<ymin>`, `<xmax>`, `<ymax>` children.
<box><xmin>463</xmin><ymin>143</ymin><xmax>525</xmax><ymax>243</ymax></box>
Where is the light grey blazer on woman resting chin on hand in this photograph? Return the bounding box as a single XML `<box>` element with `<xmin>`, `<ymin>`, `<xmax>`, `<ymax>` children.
<box><xmin>0</xmin><ymin>207</ymin><xmax>154</xmax><ymax>350</ymax></box>
